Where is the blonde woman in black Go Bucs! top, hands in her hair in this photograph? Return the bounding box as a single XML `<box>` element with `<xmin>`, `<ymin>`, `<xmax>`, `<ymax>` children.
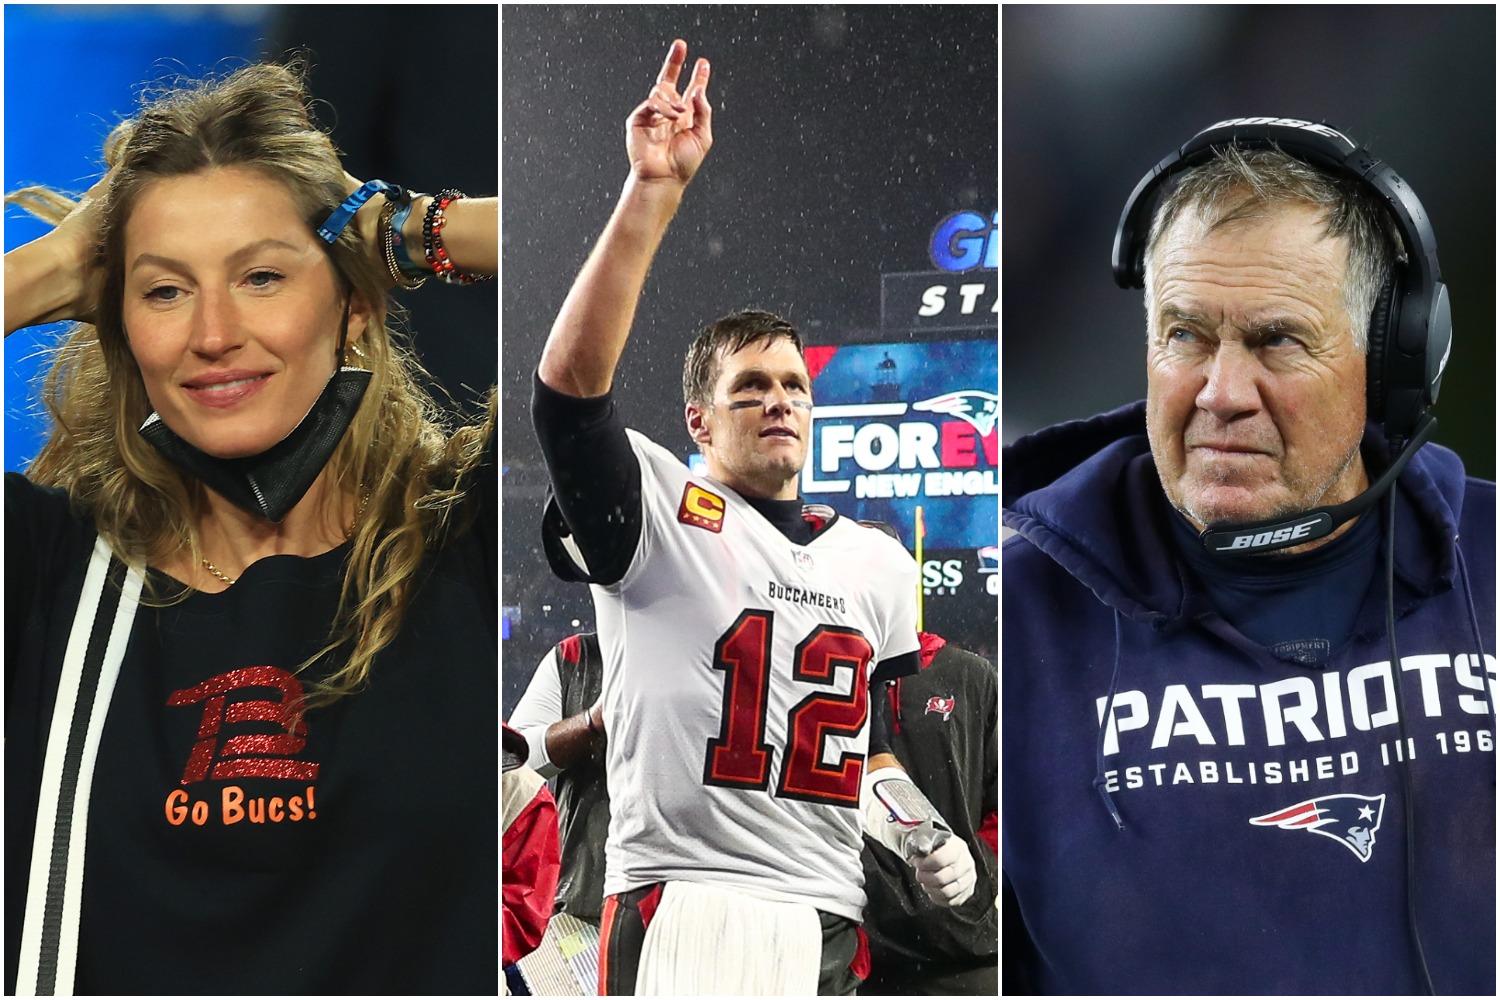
<box><xmin>5</xmin><ymin>64</ymin><xmax>498</xmax><ymax>994</ymax></box>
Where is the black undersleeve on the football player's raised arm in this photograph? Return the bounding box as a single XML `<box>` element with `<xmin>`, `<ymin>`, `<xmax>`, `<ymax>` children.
<box><xmin>531</xmin><ymin>376</ymin><xmax>642</xmax><ymax>585</ymax></box>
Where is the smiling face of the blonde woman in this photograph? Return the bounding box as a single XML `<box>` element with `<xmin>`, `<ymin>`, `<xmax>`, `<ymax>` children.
<box><xmin>123</xmin><ymin>166</ymin><xmax>369</xmax><ymax>459</ymax></box>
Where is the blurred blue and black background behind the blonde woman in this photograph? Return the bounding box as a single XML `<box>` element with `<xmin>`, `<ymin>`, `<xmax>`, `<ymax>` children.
<box><xmin>5</xmin><ymin>4</ymin><xmax>500</xmax><ymax>471</ymax></box>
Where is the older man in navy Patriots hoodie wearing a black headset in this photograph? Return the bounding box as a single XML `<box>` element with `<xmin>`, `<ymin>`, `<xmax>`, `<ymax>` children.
<box><xmin>1002</xmin><ymin>118</ymin><xmax>1496</xmax><ymax>996</ymax></box>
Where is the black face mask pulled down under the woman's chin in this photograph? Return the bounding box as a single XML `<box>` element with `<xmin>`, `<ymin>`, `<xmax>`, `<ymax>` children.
<box><xmin>141</xmin><ymin>367</ymin><xmax>371</xmax><ymax>522</ymax></box>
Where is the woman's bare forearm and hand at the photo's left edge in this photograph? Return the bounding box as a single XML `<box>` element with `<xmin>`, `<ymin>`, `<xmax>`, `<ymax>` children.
<box><xmin>5</xmin><ymin>174</ymin><xmax>110</xmax><ymax>336</ymax></box>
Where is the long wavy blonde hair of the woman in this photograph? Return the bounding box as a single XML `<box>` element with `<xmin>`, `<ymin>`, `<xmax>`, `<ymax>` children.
<box><xmin>6</xmin><ymin>63</ymin><xmax>495</xmax><ymax>708</ymax></box>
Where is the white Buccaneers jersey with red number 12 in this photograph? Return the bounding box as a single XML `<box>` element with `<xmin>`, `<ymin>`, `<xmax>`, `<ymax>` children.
<box><xmin>579</xmin><ymin>430</ymin><xmax>918</xmax><ymax>921</ymax></box>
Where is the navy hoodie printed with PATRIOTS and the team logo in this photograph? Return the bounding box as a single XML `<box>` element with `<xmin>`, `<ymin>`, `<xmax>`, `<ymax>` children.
<box><xmin>1001</xmin><ymin>403</ymin><xmax>1496</xmax><ymax>996</ymax></box>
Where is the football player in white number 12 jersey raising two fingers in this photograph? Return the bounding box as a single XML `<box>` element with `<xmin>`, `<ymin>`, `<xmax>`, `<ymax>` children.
<box><xmin>533</xmin><ymin>40</ymin><xmax>975</xmax><ymax>994</ymax></box>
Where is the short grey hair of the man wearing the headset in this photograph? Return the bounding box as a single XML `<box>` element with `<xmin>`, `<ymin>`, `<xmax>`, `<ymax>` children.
<box><xmin>1146</xmin><ymin>145</ymin><xmax>1401</xmax><ymax>354</ymax></box>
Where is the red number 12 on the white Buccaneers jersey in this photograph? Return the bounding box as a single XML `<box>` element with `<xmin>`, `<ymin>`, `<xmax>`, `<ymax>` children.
<box><xmin>704</xmin><ymin>609</ymin><xmax>875</xmax><ymax>808</ymax></box>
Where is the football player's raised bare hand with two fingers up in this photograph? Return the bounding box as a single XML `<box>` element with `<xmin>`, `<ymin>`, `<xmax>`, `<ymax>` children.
<box><xmin>626</xmin><ymin>39</ymin><xmax>714</xmax><ymax>184</ymax></box>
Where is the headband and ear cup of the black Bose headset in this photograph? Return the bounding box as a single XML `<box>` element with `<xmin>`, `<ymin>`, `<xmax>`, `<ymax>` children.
<box><xmin>1113</xmin><ymin>118</ymin><xmax>1454</xmax><ymax>442</ymax></box>
